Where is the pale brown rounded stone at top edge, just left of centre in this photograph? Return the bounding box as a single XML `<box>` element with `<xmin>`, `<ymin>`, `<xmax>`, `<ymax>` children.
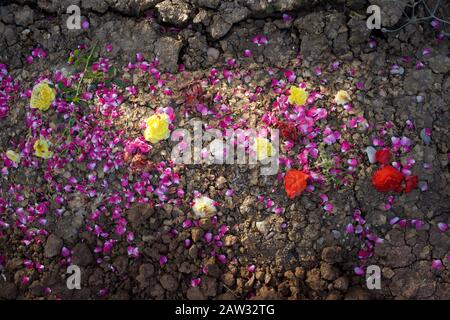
<box><xmin>156</xmin><ymin>0</ymin><xmax>193</xmax><ymax>27</ymax></box>
